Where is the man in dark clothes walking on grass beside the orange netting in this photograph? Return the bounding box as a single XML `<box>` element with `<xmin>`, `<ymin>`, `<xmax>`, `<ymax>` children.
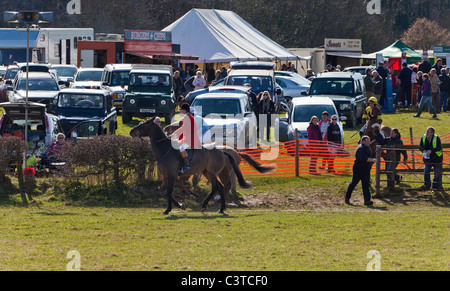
<box><xmin>345</xmin><ymin>135</ymin><xmax>376</xmax><ymax>206</ymax></box>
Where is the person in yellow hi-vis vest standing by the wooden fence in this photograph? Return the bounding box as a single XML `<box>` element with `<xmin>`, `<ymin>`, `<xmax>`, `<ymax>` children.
<box><xmin>419</xmin><ymin>126</ymin><xmax>444</xmax><ymax>191</ymax></box>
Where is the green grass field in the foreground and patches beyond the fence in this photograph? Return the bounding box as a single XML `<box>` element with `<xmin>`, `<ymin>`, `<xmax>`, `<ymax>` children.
<box><xmin>0</xmin><ymin>112</ymin><xmax>450</xmax><ymax>271</ymax></box>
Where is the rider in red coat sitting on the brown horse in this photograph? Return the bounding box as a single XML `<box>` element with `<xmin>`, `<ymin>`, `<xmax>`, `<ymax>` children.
<box><xmin>172</xmin><ymin>103</ymin><xmax>202</xmax><ymax>173</ymax></box>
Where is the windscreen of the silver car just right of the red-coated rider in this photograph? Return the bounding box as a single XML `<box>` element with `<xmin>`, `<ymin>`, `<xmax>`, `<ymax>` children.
<box><xmin>192</xmin><ymin>98</ymin><xmax>242</xmax><ymax>116</ymax></box>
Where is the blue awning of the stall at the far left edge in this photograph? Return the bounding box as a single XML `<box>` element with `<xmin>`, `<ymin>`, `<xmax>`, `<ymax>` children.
<box><xmin>0</xmin><ymin>29</ymin><xmax>39</xmax><ymax>49</ymax></box>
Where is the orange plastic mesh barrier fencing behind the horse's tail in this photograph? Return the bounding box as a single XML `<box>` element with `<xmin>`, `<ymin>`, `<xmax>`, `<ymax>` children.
<box><xmin>240</xmin><ymin>133</ymin><xmax>450</xmax><ymax>185</ymax></box>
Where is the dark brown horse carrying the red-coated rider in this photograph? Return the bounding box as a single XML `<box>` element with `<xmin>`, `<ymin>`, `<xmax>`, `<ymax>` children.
<box><xmin>130</xmin><ymin>118</ymin><xmax>252</xmax><ymax>214</ymax></box>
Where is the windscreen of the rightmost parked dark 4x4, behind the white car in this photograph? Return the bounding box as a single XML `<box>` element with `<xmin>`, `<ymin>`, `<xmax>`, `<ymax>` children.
<box><xmin>309</xmin><ymin>78</ymin><xmax>355</xmax><ymax>96</ymax></box>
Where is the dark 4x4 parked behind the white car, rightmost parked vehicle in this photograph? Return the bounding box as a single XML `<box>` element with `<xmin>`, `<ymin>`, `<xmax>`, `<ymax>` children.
<box><xmin>304</xmin><ymin>72</ymin><xmax>367</xmax><ymax>127</ymax></box>
